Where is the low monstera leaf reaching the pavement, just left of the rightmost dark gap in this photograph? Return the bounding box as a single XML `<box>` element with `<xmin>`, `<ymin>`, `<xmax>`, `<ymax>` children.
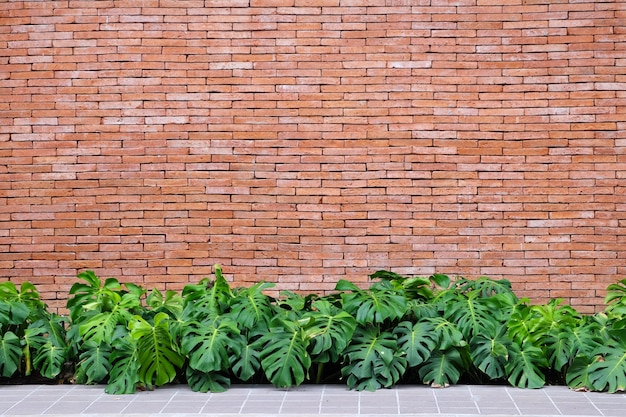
<box><xmin>506</xmin><ymin>342</ymin><xmax>548</xmax><ymax>388</ymax></box>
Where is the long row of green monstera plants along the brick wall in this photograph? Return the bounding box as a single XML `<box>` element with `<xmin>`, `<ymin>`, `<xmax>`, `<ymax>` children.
<box><xmin>0</xmin><ymin>265</ymin><xmax>626</xmax><ymax>394</ymax></box>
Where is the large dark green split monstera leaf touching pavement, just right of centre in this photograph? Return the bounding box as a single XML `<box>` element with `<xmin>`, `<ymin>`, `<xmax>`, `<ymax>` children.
<box><xmin>341</xmin><ymin>325</ymin><xmax>407</xmax><ymax>391</ymax></box>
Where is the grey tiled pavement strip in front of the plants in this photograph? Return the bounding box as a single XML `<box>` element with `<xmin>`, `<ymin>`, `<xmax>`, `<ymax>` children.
<box><xmin>0</xmin><ymin>385</ymin><xmax>626</xmax><ymax>417</ymax></box>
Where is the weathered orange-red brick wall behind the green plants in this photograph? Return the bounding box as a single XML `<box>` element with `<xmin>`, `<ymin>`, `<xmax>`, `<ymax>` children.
<box><xmin>0</xmin><ymin>0</ymin><xmax>626</xmax><ymax>311</ymax></box>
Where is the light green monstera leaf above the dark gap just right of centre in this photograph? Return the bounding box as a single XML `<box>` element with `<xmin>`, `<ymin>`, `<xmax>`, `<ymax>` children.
<box><xmin>305</xmin><ymin>300</ymin><xmax>356</xmax><ymax>362</ymax></box>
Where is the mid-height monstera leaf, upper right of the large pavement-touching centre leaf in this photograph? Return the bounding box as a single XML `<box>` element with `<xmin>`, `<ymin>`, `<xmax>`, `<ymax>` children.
<box><xmin>393</xmin><ymin>321</ymin><xmax>437</xmax><ymax>367</ymax></box>
